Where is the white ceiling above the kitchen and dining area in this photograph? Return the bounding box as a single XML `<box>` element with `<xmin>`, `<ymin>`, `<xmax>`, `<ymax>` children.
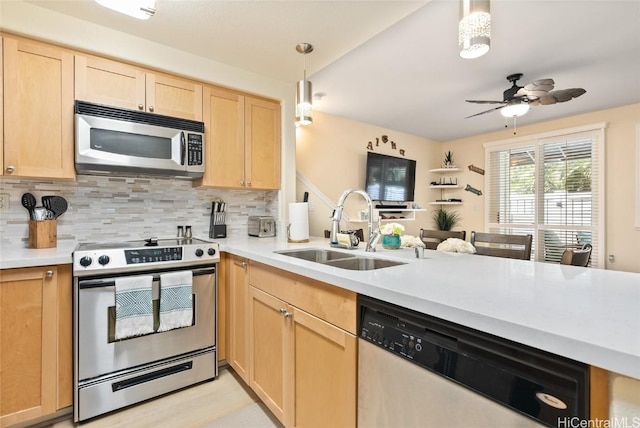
<box><xmin>22</xmin><ymin>0</ymin><xmax>640</xmax><ymax>141</ymax></box>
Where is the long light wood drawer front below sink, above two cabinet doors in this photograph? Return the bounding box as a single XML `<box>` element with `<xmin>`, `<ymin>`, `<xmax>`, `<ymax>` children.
<box><xmin>249</xmin><ymin>262</ymin><xmax>356</xmax><ymax>334</ymax></box>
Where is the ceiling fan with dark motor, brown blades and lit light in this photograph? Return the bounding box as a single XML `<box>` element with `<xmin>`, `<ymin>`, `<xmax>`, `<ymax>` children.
<box><xmin>465</xmin><ymin>73</ymin><xmax>587</xmax><ymax>119</ymax></box>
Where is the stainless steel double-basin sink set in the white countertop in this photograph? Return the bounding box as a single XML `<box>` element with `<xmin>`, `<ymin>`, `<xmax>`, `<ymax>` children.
<box><xmin>275</xmin><ymin>248</ymin><xmax>406</xmax><ymax>270</ymax></box>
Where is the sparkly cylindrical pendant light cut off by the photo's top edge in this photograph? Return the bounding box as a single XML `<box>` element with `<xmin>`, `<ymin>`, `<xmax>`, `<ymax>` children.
<box><xmin>458</xmin><ymin>0</ymin><xmax>491</xmax><ymax>59</ymax></box>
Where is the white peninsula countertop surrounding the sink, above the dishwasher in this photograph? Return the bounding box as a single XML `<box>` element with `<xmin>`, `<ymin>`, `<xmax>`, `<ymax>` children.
<box><xmin>216</xmin><ymin>237</ymin><xmax>640</xmax><ymax>379</ymax></box>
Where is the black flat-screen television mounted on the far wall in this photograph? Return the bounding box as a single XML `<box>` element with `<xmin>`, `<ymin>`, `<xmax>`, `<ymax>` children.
<box><xmin>365</xmin><ymin>152</ymin><xmax>416</xmax><ymax>204</ymax></box>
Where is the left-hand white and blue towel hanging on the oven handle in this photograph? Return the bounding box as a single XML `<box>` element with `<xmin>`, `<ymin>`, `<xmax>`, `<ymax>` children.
<box><xmin>115</xmin><ymin>275</ymin><xmax>153</xmax><ymax>340</ymax></box>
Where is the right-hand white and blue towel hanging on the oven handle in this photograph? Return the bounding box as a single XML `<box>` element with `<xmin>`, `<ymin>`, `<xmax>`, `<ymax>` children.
<box><xmin>158</xmin><ymin>270</ymin><xmax>193</xmax><ymax>331</ymax></box>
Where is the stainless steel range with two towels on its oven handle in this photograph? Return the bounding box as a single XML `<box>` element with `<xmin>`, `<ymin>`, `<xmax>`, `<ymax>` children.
<box><xmin>73</xmin><ymin>238</ymin><xmax>220</xmax><ymax>422</ymax></box>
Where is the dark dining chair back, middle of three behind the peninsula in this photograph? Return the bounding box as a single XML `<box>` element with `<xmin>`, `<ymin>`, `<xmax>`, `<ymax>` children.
<box><xmin>470</xmin><ymin>231</ymin><xmax>533</xmax><ymax>260</ymax></box>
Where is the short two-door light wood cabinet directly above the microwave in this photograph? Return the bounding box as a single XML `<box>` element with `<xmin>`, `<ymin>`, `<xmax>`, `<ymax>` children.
<box><xmin>75</xmin><ymin>55</ymin><xmax>202</xmax><ymax>121</ymax></box>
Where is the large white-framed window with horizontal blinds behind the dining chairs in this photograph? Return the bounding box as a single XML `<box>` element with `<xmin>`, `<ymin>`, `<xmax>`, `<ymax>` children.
<box><xmin>484</xmin><ymin>124</ymin><xmax>604</xmax><ymax>267</ymax></box>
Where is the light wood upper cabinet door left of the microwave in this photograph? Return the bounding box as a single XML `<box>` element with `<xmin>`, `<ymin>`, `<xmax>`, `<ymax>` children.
<box><xmin>3</xmin><ymin>38</ymin><xmax>75</xmax><ymax>179</ymax></box>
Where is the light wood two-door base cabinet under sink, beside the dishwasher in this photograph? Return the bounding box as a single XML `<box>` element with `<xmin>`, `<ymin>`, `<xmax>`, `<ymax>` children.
<box><xmin>249</xmin><ymin>262</ymin><xmax>357</xmax><ymax>427</ymax></box>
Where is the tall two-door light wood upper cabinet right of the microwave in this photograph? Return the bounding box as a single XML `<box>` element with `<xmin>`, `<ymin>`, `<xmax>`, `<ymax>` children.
<box><xmin>194</xmin><ymin>86</ymin><xmax>281</xmax><ymax>190</ymax></box>
